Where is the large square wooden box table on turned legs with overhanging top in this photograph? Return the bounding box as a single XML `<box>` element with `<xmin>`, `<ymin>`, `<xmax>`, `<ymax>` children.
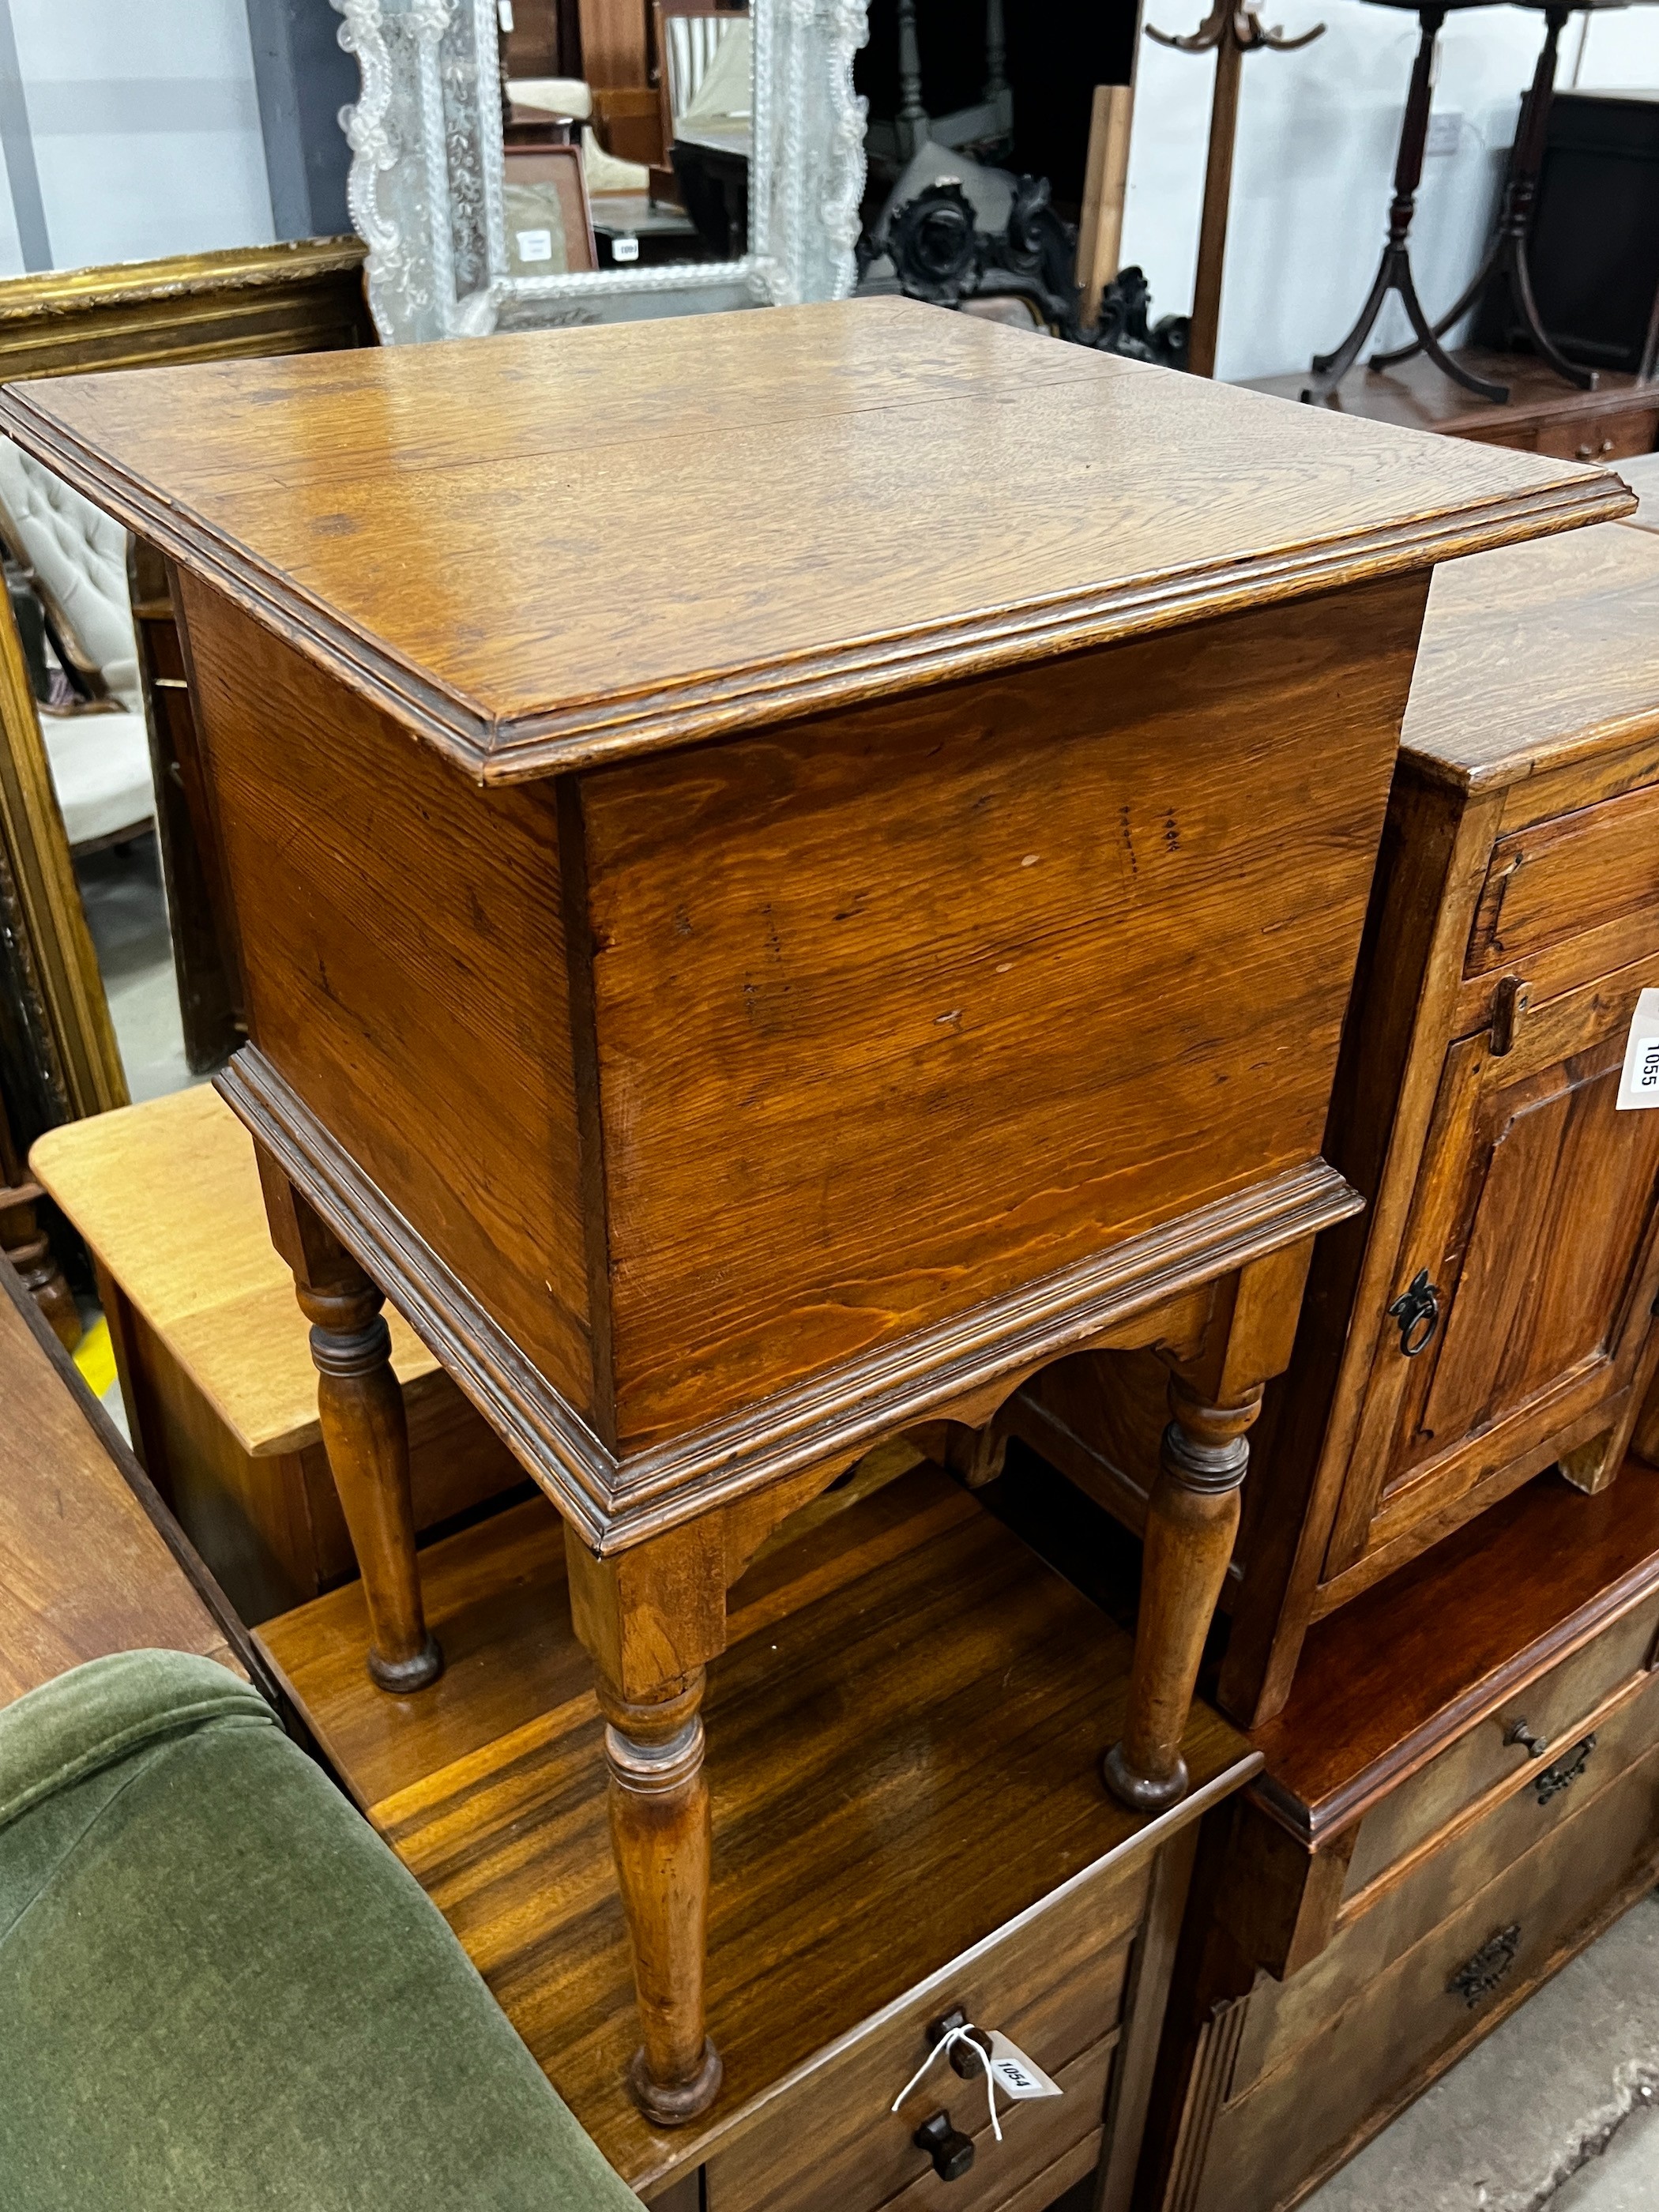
<box><xmin>0</xmin><ymin>301</ymin><xmax>1631</xmax><ymax>2124</ymax></box>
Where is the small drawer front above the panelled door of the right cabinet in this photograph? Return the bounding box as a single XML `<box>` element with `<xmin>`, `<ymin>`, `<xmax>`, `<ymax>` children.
<box><xmin>1465</xmin><ymin>783</ymin><xmax>1659</xmax><ymax>976</ymax></box>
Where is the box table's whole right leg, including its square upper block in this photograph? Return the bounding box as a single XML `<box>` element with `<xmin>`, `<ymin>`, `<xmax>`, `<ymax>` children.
<box><xmin>1104</xmin><ymin>1239</ymin><xmax>1311</xmax><ymax>1811</ymax></box>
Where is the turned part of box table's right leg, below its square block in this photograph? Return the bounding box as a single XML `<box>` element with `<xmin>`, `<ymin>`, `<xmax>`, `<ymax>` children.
<box><xmin>1104</xmin><ymin>1378</ymin><xmax>1261</xmax><ymax>1811</ymax></box>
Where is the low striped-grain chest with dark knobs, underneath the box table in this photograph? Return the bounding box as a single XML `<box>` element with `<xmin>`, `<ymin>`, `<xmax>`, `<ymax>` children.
<box><xmin>259</xmin><ymin>1454</ymin><xmax>1256</xmax><ymax>2212</ymax></box>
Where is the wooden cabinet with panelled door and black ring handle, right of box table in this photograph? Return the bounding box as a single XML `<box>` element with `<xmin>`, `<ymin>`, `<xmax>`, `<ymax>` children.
<box><xmin>1013</xmin><ymin>525</ymin><xmax>1659</xmax><ymax>1725</ymax></box>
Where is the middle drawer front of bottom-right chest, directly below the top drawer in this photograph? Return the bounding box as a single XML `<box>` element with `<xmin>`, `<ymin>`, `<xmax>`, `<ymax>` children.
<box><xmin>1232</xmin><ymin>1676</ymin><xmax>1659</xmax><ymax>2095</ymax></box>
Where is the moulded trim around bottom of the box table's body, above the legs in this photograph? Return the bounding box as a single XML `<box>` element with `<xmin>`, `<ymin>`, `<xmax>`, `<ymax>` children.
<box><xmin>215</xmin><ymin>1046</ymin><xmax>1363</xmax><ymax>1555</ymax></box>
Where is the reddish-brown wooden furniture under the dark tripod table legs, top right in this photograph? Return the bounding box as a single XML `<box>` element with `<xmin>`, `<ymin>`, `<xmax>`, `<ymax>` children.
<box><xmin>1247</xmin><ymin>345</ymin><xmax>1659</xmax><ymax>462</ymax></box>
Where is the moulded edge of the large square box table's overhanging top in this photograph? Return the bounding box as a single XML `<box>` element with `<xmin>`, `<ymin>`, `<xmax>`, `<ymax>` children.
<box><xmin>0</xmin><ymin>385</ymin><xmax>1637</xmax><ymax>783</ymax></box>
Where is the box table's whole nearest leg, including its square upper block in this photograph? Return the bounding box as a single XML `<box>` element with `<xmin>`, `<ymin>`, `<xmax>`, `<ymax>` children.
<box><xmin>564</xmin><ymin>1515</ymin><xmax>725</xmax><ymax>2128</ymax></box>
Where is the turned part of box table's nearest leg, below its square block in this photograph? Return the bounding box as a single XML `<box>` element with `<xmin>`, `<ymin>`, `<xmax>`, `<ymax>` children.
<box><xmin>600</xmin><ymin>1668</ymin><xmax>721</xmax><ymax>2128</ymax></box>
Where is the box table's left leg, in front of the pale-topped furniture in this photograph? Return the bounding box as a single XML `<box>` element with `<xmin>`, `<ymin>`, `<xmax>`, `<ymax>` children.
<box><xmin>259</xmin><ymin>1153</ymin><xmax>445</xmax><ymax>1697</ymax></box>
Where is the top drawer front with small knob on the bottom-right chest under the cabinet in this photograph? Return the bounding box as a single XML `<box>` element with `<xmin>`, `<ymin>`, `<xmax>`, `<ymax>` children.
<box><xmin>1343</xmin><ymin>1597</ymin><xmax>1659</xmax><ymax>1898</ymax></box>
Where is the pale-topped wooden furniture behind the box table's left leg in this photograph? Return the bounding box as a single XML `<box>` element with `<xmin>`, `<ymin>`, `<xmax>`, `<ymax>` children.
<box><xmin>31</xmin><ymin>1086</ymin><xmax>525</xmax><ymax>1621</ymax></box>
